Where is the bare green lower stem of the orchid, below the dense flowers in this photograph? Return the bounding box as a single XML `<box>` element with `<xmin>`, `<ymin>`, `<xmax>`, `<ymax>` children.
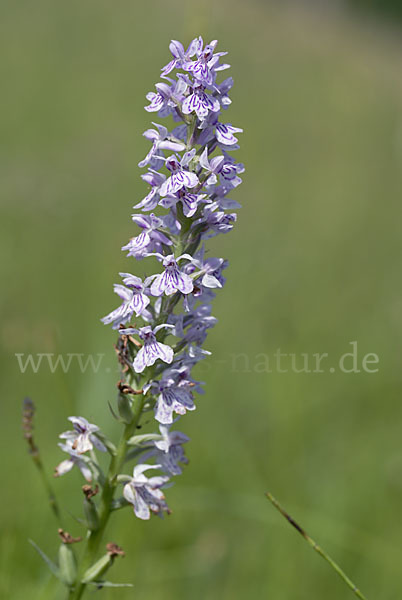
<box><xmin>68</xmin><ymin>395</ymin><xmax>144</xmax><ymax>600</ymax></box>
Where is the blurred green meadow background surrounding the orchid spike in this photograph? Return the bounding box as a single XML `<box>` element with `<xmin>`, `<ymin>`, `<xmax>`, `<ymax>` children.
<box><xmin>0</xmin><ymin>0</ymin><xmax>402</xmax><ymax>600</ymax></box>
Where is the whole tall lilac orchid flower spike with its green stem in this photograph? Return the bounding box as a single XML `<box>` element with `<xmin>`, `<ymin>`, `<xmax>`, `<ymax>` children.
<box><xmin>28</xmin><ymin>37</ymin><xmax>244</xmax><ymax>598</ymax></box>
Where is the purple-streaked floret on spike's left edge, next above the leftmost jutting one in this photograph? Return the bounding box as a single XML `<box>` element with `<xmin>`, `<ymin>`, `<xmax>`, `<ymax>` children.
<box><xmin>122</xmin><ymin>213</ymin><xmax>172</xmax><ymax>258</ymax></box>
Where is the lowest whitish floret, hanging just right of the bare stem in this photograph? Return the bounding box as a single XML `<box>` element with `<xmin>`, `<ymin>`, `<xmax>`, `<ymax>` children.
<box><xmin>123</xmin><ymin>464</ymin><xmax>169</xmax><ymax>520</ymax></box>
